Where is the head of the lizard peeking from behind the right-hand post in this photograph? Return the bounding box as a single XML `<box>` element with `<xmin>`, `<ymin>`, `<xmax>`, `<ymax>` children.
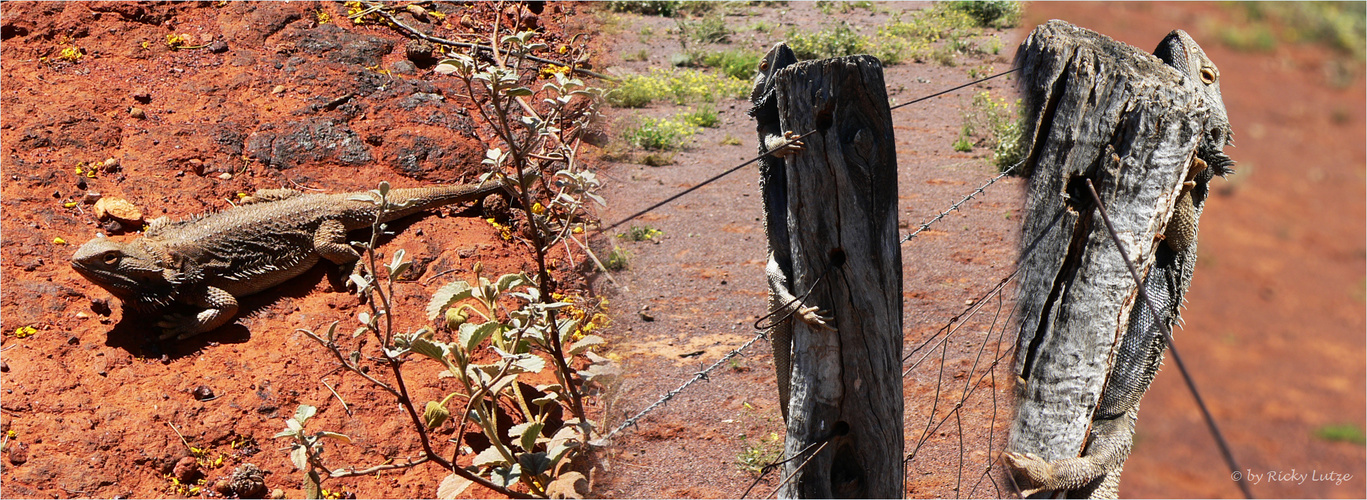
<box><xmin>1154</xmin><ymin>30</ymin><xmax>1234</xmax><ymax>176</ymax></box>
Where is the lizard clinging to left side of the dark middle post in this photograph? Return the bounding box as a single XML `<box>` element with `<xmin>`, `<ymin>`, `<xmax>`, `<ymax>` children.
<box><xmin>749</xmin><ymin>42</ymin><xmax>830</xmax><ymax>421</ymax></box>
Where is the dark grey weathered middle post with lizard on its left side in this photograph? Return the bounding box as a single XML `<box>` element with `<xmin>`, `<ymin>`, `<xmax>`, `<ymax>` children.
<box><xmin>776</xmin><ymin>56</ymin><xmax>904</xmax><ymax>499</ymax></box>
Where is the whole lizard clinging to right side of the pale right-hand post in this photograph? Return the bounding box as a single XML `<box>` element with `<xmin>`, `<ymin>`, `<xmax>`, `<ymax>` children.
<box><xmin>1003</xmin><ymin>30</ymin><xmax>1234</xmax><ymax>499</ymax></box>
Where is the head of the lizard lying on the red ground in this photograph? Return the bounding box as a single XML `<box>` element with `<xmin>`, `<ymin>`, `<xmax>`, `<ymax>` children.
<box><xmin>71</xmin><ymin>236</ymin><xmax>175</xmax><ymax>309</ymax></box>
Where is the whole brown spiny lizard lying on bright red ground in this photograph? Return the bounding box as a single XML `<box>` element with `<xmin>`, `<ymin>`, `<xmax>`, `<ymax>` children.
<box><xmin>71</xmin><ymin>174</ymin><xmax>522</xmax><ymax>339</ymax></box>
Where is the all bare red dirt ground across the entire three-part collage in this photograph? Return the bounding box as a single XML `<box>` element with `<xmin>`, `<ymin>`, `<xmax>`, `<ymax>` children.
<box><xmin>0</xmin><ymin>1</ymin><xmax>1367</xmax><ymax>497</ymax></box>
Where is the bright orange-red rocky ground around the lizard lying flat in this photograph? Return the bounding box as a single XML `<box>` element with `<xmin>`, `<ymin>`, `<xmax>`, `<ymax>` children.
<box><xmin>0</xmin><ymin>1</ymin><xmax>606</xmax><ymax>497</ymax></box>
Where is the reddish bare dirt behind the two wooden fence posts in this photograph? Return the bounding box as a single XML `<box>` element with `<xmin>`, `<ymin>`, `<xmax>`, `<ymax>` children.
<box><xmin>597</xmin><ymin>3</ymin><xmax>1367</xmax><ymax>497</ymax></box>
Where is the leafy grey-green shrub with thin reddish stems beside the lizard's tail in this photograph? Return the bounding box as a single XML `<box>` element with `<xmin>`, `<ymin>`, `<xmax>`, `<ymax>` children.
<box><xmin>288</xmin><ymin>27</ymin><xmax>615</xmax><ymax>497</ymax></box>
